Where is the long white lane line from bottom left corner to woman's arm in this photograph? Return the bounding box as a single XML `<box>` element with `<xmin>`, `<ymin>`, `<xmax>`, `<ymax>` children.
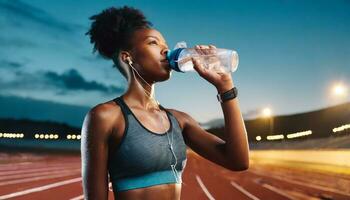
<box><xmin>0</xmin><ymin>177</ymin><xmax>81</xmax><ymax>200</ymax></box>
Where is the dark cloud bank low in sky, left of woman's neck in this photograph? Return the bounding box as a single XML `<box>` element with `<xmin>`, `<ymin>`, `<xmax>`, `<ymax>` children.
<box><xmin>0</xmin><ymin>69</ymin><xmax>124</xmax><ymax>95</ymax></box>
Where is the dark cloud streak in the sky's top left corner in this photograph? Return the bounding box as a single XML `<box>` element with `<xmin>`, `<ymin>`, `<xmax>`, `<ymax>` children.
<box><xmin>0</xmin><ymin>0</ymin><xmax>84</xmax><ymax>33</ymax></box>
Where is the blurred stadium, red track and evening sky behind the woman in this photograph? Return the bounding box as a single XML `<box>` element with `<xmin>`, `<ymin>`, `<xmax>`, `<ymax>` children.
<box><xmin>0</xmin><ymin>0</ymin><xmax>350</xmax><ymax>200</ymax></box>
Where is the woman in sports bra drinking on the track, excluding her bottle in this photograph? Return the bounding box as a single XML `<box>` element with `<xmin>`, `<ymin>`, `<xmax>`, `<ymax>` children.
<box><xmin>81</xmin><ymin>6</ymin><xmax>249</xmax><ymax>200</ymax></box>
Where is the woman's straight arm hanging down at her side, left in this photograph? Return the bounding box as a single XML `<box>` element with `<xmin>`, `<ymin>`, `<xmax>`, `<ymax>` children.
<box><xmin>81</xmin><ymin>106</ymin><xmax>111</xmax><ymax>200</ymax></box>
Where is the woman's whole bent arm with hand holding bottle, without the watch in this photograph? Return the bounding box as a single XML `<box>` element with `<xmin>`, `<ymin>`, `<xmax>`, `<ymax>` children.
<box><xmin>170</xmin><ymin>45</ymin><xmax>249</xmax><ymax>171</ymax></box>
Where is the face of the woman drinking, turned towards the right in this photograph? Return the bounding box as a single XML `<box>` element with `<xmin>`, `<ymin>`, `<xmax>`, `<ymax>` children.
<box><xmin>125</xmin><ymin>29</ymin><xmax>171</xmax><ymax>83</ymax></box>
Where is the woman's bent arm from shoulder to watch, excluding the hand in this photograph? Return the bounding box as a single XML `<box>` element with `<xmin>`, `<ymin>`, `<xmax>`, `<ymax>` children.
<box><xmin>170</xmin><ymin>99</ymin><xmax>249</xmax><ymax>171</ymax></box>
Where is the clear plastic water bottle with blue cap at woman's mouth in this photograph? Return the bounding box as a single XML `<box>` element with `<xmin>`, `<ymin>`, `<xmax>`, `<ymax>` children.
<box><xmin>167</xmin><ymin>42</ymin><xmax>238</xmax><ymax>73</ymax></box>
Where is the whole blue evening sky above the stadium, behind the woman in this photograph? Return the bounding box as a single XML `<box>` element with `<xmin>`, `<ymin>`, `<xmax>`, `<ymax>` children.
<box><xmin>0</xmin><ymin>0</ymin><xmax>350</xmax><ymax>122</ymax></box>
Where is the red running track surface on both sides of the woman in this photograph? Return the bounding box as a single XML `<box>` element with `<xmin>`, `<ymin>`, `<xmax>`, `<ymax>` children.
<box><xmin>0</xmin><ymin>152</ymin><xmax>350</xmax><ymax>200</ymax></box>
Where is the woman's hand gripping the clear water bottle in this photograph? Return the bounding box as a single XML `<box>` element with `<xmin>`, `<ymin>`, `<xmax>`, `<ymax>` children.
<box><xmin>192</xmin><ymin>45</ymin><xmax>233</xmax><ymax>93</ymax></box>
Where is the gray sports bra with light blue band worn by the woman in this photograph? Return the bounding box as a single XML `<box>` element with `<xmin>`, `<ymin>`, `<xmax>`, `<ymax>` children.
<box><xmin>108</xmin><ymin>96</ymin><xmax>187</xmax><ymax>191</ymax></box>
